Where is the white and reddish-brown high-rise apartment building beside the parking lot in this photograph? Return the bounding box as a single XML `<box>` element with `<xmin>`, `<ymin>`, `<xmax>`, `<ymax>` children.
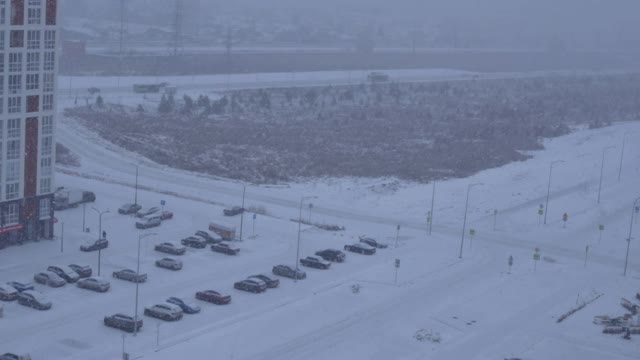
<box><xmin>0</xmin><ymin>0</ymin><xmax>58</xmax><ymax>247</ymax></box>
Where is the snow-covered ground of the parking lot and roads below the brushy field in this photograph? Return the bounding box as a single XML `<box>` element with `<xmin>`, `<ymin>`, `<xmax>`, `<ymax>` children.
<box><xmin>0</xmin><ymin>72</ymin><xmax>640</xmax><ymax>360</ymax></box>
